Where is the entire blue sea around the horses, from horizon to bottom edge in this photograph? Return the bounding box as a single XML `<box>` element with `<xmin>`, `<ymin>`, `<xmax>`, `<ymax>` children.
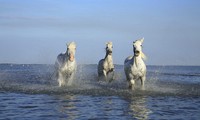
<box><xmin>0</xmin><ymin>64</ymin><xmax>200</xmax><ymax>120</ymax></box>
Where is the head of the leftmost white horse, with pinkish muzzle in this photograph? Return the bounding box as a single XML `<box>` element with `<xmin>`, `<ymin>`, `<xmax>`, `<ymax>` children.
<box><xmin>66</xmin><ymin>42</ymin><xmax>76</xmax><ymax>62</ymax></box>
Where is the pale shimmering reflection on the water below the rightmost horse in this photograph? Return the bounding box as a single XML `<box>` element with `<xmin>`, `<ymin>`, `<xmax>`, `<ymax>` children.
<box><xmin>129</xmin><ymin>96</ymin><xmax>151</xmax><ymax>120</ymax></box>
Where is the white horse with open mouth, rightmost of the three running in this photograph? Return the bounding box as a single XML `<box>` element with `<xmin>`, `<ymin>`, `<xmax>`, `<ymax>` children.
<box><xmin>124</xmin><ymin>38</ymin><xmax>146</xmax><ymax>89</ymax></box>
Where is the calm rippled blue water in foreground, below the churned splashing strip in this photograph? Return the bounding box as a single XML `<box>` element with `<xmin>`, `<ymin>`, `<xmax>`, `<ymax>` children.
<box><xmin>0</xmin><ymin>92</ymin><xmax>200</xmax><ymax>120</ymax></box>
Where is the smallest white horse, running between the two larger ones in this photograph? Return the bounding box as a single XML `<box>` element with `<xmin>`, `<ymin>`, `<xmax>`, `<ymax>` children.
<box><xmin>98</xmin><ymin>42</ymin><xmax>114</xmax><ymax>82</ymax></box>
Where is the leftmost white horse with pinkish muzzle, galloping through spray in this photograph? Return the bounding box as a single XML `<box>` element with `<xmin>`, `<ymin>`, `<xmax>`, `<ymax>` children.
<box><xmin>55</xmin><ymin>42</ymin><xmax>77</xmax><ymax>87</ymax></box>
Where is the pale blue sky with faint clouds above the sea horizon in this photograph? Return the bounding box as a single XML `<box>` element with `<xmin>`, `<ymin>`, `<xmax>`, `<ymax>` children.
<box><xmin>0</xmin><ymin>0</ymin><xmax>200</xmax><ymax>65</ymax></box>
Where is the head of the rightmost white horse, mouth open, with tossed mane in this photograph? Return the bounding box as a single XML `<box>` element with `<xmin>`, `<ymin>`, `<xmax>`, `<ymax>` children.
<box><xmin>133</xmin><ymin>38</ymin><xmax>146</xmax><ymax>59</ymax></box>
